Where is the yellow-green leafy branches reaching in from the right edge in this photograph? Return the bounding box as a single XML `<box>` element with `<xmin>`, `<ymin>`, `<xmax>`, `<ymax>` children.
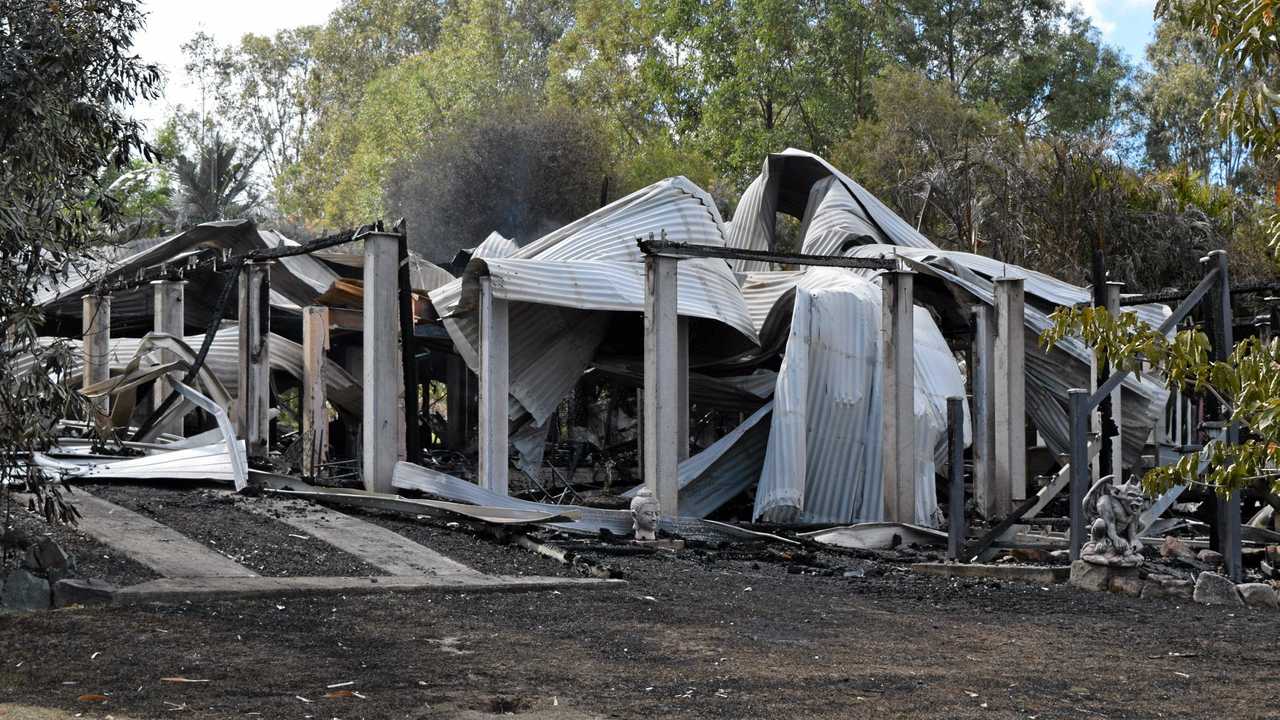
<box><xmin>1042</xmin><ymin>0</ymin><xmax>1280</xmax><ymax>497</ymax></box>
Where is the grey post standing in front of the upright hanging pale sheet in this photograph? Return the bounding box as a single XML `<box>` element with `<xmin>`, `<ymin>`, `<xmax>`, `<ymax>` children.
<box><xmin>879</xmin><ymin>270</ymin><xmax>915</xmax><ymax>523</ymax></box>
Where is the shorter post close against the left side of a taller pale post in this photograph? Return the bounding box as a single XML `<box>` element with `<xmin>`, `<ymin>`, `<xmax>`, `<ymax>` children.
<box><xmin>970</xmin><ymin>305</ymin><xmax>1012</xmax><ymax>518</ymax></box>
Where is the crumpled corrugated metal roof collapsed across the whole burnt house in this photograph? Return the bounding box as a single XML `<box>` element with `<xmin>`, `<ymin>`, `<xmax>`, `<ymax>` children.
<box><xmin>22</xmin><ymin>150</ymin><xmax>1167</xmax><ymax>525</ymax></box>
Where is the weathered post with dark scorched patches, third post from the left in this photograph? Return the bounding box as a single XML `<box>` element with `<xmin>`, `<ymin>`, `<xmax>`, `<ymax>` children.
<box><xmin>236</xmin><ymin>263</ymin><xmax>271</xmax><ymax>459</ymax></box>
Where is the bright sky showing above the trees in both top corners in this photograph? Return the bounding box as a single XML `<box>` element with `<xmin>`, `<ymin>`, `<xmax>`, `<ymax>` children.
<box><xmin>134</xmin><ymin>0</ymin><xmax>1155</xmax><ymax>128</ymax></box>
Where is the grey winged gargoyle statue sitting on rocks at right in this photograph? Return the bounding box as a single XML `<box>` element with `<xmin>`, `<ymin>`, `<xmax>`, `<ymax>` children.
<box><xmin>1080</xmin><ymin>475</ymin><xmax>1147</xmax><ymax>568</ymax></box>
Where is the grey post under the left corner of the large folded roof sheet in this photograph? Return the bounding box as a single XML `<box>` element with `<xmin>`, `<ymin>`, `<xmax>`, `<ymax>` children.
<box><xmin>480</xmin><ymin>275</ymin><xmax>511</xmax><ymax>495</ymax></box>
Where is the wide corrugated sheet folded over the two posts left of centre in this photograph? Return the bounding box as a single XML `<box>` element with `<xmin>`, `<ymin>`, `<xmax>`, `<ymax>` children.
<box><xmin>431</xmin><ymin>178</ymin><xmax>755</xmax><ymax>425</ymax></box>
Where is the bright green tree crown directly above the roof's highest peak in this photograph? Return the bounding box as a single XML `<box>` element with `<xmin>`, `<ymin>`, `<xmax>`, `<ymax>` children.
<box><xmin>663</xmin><ymin>0</ymin><xmax>884</xmax><ymax>183</ymax></box>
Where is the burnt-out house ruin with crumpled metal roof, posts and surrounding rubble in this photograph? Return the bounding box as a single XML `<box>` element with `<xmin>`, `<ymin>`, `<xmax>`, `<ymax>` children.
<box><xmin>5</xmin><ymin>150</ymin><xmax>1280</xmax><ymax>607</ymax></box>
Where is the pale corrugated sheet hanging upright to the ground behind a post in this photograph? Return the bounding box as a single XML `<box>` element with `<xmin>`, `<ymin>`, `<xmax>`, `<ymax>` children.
<box><xmin>754</xmin><ymin>268</ymin><xmax>968</xmax><ymax>525</ymax></box>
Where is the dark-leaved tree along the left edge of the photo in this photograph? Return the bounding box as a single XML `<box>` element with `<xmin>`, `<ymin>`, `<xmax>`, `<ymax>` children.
<box><xmin>0</xmin><ymin>0</ymin><xmax>160</xmax><ymax>519</ymax></box>
